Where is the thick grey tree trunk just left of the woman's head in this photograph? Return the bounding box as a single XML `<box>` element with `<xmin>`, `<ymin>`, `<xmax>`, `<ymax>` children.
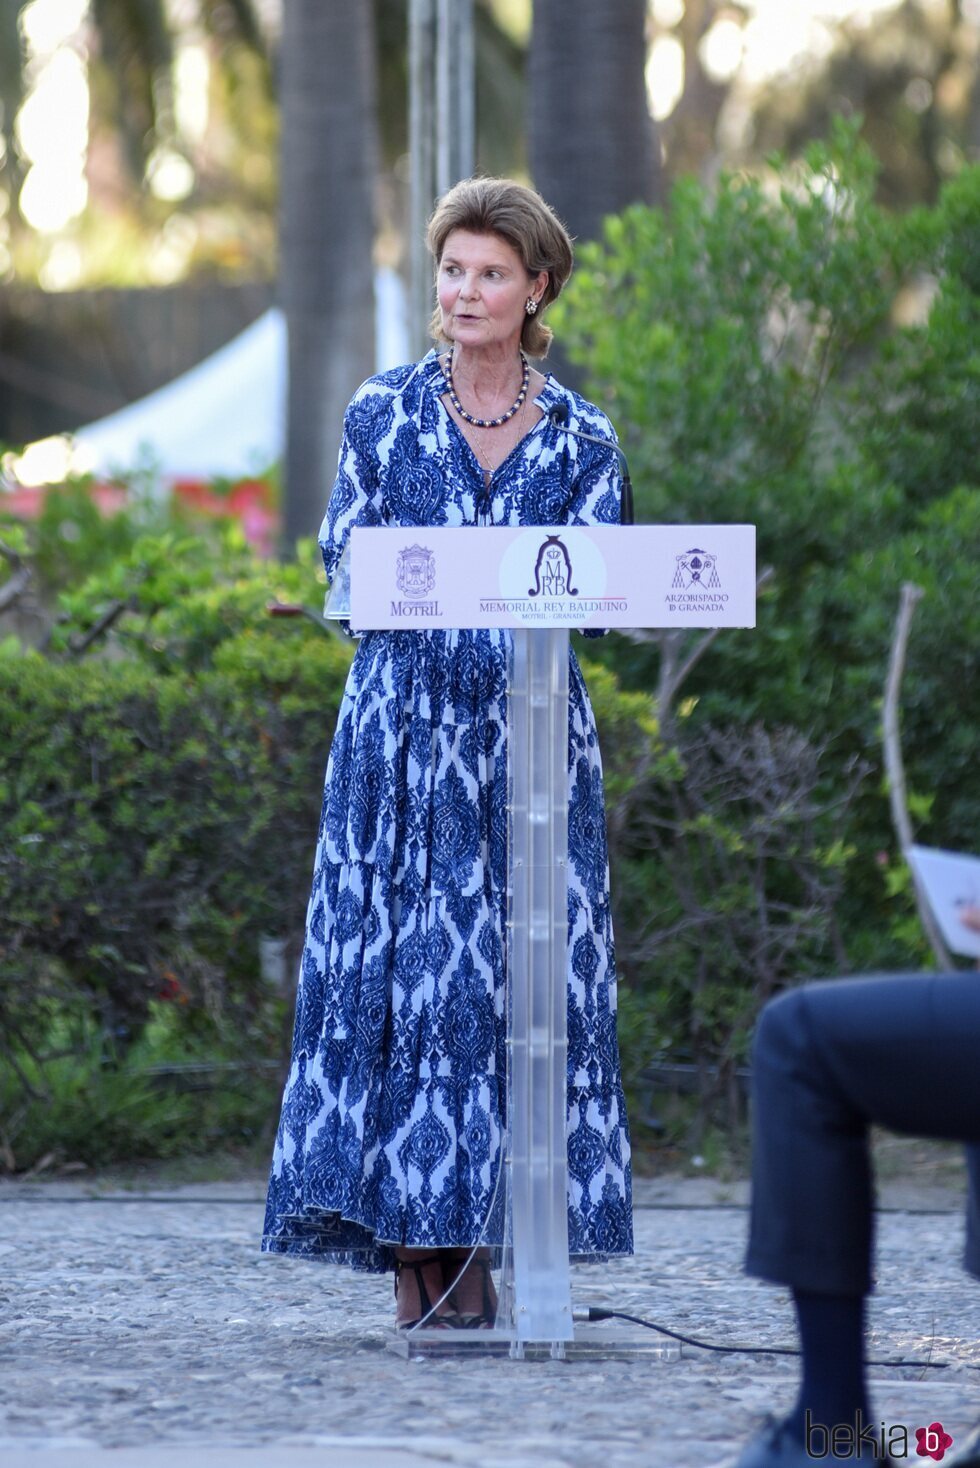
<box><xmin>280</xmin><ymin>0</ymin><xmax>377</xmax><ymax>551</ymax></box>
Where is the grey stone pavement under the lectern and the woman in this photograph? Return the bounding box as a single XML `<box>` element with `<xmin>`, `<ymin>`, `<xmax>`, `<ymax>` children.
<box><xmin>0</xmin><ymin>1179</ymin><xmax>980</xmax><ymax>1468</ymax></box>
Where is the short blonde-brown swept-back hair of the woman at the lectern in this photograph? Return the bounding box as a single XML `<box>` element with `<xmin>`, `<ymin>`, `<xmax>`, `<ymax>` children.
<box><xmin>425</xmin><ymin>178</ymin><xmax>572</xmax><ymax>357</ymax></box>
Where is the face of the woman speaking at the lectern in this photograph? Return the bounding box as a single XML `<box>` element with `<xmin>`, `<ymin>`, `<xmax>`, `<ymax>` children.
<box><xmin>437</xmin><ymin>229</ymin><xmax>547</xmax><ymax>352</ymax></box>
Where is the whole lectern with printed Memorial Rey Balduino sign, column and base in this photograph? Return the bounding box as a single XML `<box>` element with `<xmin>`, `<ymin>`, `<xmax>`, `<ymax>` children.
<box><xmin>327</xmin><ymin>526</ymin><xmax>756</xmax><ymax>1358</ymax></box>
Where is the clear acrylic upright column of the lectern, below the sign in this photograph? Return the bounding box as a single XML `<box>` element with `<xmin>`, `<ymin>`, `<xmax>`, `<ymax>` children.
<box><xmin>497</xmin><ymin>630</ymin><xmax>575</xmax><ymax>1355</ymax></box>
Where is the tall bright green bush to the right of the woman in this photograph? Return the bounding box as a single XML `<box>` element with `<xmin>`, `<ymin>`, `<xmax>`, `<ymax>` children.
<box><xmin>560</xmin><ymin>125</ymin><xmax>980</xmax><ymax>986</ymax></box>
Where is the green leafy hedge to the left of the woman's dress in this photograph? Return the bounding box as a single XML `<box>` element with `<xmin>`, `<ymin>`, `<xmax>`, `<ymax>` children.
<box><xmin>0</xmin><ymin>531</ymin><xmax>359</xmax><ymax>1166</ymax></box>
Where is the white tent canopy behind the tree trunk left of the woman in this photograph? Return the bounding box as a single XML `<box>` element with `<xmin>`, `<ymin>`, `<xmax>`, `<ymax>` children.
<box><xmin>72</xmin><ymin>270</ymin><xmax>409</xmax><ymax>479</ymax></box>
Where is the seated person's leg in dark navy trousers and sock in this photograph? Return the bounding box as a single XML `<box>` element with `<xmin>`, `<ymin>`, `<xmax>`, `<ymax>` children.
<box><xmin>739</xmin><ymin>973</ymin><xmax>980</xmax><ymax>1468</ymax></box>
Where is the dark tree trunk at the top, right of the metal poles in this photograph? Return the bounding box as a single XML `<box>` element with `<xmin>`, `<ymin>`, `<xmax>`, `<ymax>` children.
<box><xmin>528</xmin><ymin>0</ymin><xmax>662</xmax><ymax>239</ymax></box>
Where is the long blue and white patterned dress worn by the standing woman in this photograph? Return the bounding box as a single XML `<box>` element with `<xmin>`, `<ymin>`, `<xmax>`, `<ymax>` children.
<box><xmin>263</xmin><ymin>352</ymin><xmax>632</xmax><ymax>1271</ymax></box>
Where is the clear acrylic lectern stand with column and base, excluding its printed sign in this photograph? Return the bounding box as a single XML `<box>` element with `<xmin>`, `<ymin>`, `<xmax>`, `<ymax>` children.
<box><xmin>324</xmin><ymin>527</ymin><xmax>754</xmax><ymax>1361</ymax></box>
